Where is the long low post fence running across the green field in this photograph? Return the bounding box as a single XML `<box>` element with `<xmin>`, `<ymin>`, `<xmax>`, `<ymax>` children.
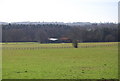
<box><xmin>2</xmin><ymin>44</ymin><xmax>118</xmax><ymax>50</ymax></box>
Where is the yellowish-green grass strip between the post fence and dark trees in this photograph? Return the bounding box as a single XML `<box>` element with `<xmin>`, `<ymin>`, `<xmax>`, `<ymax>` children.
<box><xmin>2</xmin><ymin>42</ymin><xmax>118</xmax><ymax>48</ymax></box>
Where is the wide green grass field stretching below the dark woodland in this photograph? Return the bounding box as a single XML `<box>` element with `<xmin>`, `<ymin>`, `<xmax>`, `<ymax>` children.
<box><xmin>2</xmin><ymin>42</ymin><xmax>118</xmax><ymax>79</ymax></box>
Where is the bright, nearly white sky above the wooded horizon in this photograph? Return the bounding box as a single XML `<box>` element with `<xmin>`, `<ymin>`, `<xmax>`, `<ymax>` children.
<box><xmin>0</xmin><ymin>0</ymin><xmax>119</xmax><ymax>23</ymax></box>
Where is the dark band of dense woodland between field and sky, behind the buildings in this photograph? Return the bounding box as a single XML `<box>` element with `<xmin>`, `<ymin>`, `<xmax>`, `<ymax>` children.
<box><xmin>2</xmin><ymin>23</ymin><xmax>120</xmax><ymax>43</ymax></box>
